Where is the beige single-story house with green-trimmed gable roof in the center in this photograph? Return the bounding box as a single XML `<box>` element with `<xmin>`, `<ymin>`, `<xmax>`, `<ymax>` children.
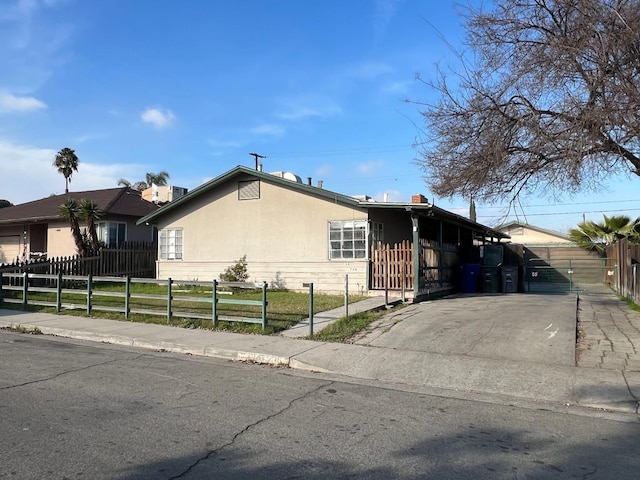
<box><xmin>138</xmin><ymin>166</ymin><xmax>508</xmax><ymax>297</ymax></box>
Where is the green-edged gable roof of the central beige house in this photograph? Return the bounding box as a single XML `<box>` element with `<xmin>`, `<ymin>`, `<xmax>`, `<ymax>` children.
<box><xmin>138</xmin><ymin>165</ymin><xmax>510</xmax><ymax>239</ymax></box>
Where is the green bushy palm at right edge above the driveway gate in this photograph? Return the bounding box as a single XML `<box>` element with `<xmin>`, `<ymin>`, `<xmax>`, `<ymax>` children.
<box><xmin>569</xmin><ymin>215</ymin><xmax>640</xmax><ymax>256</ymax></box>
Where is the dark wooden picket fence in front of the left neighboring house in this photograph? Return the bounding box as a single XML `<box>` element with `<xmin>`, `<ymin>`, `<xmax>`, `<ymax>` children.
<box><xmin>0</xmin><ymin>242</ymin><xmax>158</xmax><ymax>278</ymax></box>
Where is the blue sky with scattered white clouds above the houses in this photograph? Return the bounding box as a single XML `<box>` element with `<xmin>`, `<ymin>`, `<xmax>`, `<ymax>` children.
<box><xmin>0</xmin><ymin>0</ymin><xmax>640</xmax><ymax>230</ymax></box>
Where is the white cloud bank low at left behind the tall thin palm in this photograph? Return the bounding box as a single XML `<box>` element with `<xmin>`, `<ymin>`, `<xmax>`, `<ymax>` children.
<box><xmin>0</xmin><ymin>140</ymin><xmax>144</xmax><ymax>204</ymax></box>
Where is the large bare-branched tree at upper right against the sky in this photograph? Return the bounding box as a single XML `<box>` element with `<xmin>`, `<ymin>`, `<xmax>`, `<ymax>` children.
<box><xmin>418</xmin><ymin>0</ymin><xmax>640</xmax><ymax>201</ymax></box>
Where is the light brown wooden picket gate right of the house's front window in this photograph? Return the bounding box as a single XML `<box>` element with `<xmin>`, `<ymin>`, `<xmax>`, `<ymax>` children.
<box><xmin>371</xmin><ymin>240</ymin><xmax>414</xmax><ymax>290</ymax></box>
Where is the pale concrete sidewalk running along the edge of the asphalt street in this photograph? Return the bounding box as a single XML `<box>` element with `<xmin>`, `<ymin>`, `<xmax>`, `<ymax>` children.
<box><xmin>0</xmin><ymin>294</ymin><xmax>640</xmax><ymax>413</ymax></box>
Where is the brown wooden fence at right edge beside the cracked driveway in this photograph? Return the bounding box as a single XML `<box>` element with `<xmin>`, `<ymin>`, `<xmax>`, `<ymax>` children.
<box><xmin>607</xmin><ymin>238</ymin><xmax>640</xmax><ymax>304</ymax></box>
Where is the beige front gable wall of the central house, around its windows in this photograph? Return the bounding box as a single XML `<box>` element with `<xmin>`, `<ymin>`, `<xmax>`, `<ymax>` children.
<box><xmin>157</xmin><ymin>178</ymin><xmax>368</xmax><ymax>292</ymax></box>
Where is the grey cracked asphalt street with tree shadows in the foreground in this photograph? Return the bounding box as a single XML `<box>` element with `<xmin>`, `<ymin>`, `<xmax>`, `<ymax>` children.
<box><xmin>0</xmin><ymin>331</ymin><xmax>640</xmax><ymax>480</ymax></box>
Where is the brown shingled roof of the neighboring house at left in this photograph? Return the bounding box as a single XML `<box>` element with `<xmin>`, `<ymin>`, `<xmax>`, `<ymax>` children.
<box><xmin>0</xmin><ymin>187</ymin><xmax>158</xmax><ymax>225</ymax></box>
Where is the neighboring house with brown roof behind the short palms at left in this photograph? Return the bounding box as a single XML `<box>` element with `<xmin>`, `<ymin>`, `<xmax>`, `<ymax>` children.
<box><xmin>0</xmin><ymin>187</ymin><xmax>158</xmax><ymax>263</ymax></box>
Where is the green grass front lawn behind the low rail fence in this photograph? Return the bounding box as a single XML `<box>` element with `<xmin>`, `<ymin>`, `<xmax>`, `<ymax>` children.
<box><xmin>3</xmin><ymin>281</ymin><xmax>366</xmax><ymax>334</ymax></box>
